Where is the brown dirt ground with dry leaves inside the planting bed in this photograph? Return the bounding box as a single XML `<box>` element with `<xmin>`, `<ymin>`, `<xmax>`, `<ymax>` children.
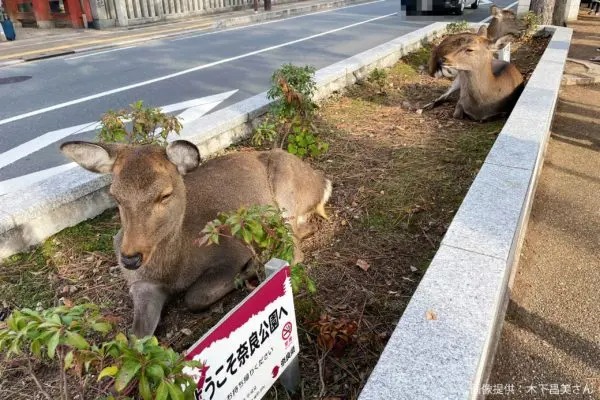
<box><xmin>0</xmin><ymin>32</ymin><xmax>547</xmax><ymax>400</ymax></box>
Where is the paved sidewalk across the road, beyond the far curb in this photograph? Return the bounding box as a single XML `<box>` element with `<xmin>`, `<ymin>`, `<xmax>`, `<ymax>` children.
<box><xmin>0</xmin><ymin>0</ymin><xmax>369</xmax><ymax>67</ymax></box>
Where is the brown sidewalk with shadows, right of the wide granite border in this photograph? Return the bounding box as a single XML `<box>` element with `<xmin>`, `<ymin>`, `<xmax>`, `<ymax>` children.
<box><xmin>483</xmin><ymin>10</ymin><xmax>600</xmax><ymax>400</ymax></box>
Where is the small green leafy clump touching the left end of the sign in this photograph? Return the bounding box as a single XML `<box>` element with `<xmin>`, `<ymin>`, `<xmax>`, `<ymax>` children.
<box><xmin>98</xmin><ymin>333</ymin><xmax>201</xmax><ymax>400</ymax></box>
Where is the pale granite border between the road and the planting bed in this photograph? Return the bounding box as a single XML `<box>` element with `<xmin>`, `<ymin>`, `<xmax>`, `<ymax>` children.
<box><xmin>0</xmin><ymin>22</ymin><xmax>447</xmax><ymax>260</ymax></box>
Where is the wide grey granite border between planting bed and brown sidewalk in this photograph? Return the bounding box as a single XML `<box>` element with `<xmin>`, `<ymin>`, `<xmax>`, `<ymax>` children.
<box><xmin>359</xmin><ymin>27</ymin><xmax>572</xmax><ymax>400</ymax></box>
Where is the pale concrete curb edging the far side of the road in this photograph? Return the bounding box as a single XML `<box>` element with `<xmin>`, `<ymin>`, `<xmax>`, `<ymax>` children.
<box><xmin>0</xmin><ymin>0</ymin><xmax>372</xmax><ymax>68</ymax></box>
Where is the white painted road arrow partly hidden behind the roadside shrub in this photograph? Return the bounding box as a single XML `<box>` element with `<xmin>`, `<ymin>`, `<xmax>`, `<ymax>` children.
<box><xmin>0</xmin><ymin>89</ymin><xmax>238</xmax><ymax>168</ymax></box>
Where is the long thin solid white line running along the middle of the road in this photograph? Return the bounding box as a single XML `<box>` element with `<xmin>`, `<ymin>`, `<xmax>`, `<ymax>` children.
<box><xmin>0</xmin><ymin>13</ymin><xmax>397</xmax><ymax>125</ymax></box>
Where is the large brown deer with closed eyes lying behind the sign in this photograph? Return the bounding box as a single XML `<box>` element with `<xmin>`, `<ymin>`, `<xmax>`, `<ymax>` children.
<box><xmin>60</xmin><ymin>140</ymin><xmax>331</xmax><ymax>337</ymax></box>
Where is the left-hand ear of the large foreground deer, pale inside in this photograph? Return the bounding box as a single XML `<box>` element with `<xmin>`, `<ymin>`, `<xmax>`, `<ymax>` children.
<box><xmin>60</xmin><ymin>141</ymin><xmax>121</xmax><ymax>174</ymax></box>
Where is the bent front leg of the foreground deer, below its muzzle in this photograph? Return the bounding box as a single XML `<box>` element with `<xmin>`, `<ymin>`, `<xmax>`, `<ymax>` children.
<box><xmin>129</xmin><ymin>281</ymin><xmax>168</xmax><ymax>338</ymax></box>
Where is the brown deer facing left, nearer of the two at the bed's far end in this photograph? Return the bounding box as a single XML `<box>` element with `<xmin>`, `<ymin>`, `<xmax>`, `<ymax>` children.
<box><xmin>428</xmin><ymin>27</ymin><xmax>524</xmax><ymax>121</ymax></box>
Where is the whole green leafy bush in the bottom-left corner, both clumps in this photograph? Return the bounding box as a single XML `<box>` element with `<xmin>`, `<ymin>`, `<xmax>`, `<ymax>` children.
<box><xmin>0</xmin><ymin>304</ymin><xmax>200</xmax><ymax>400</ymax></box>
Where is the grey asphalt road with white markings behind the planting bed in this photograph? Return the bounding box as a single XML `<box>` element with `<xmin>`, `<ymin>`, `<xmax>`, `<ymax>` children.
<box><xmin>0</xmin><ymin>0</ymin><xmax>512</xmax><ymax>189</ymax></box>
